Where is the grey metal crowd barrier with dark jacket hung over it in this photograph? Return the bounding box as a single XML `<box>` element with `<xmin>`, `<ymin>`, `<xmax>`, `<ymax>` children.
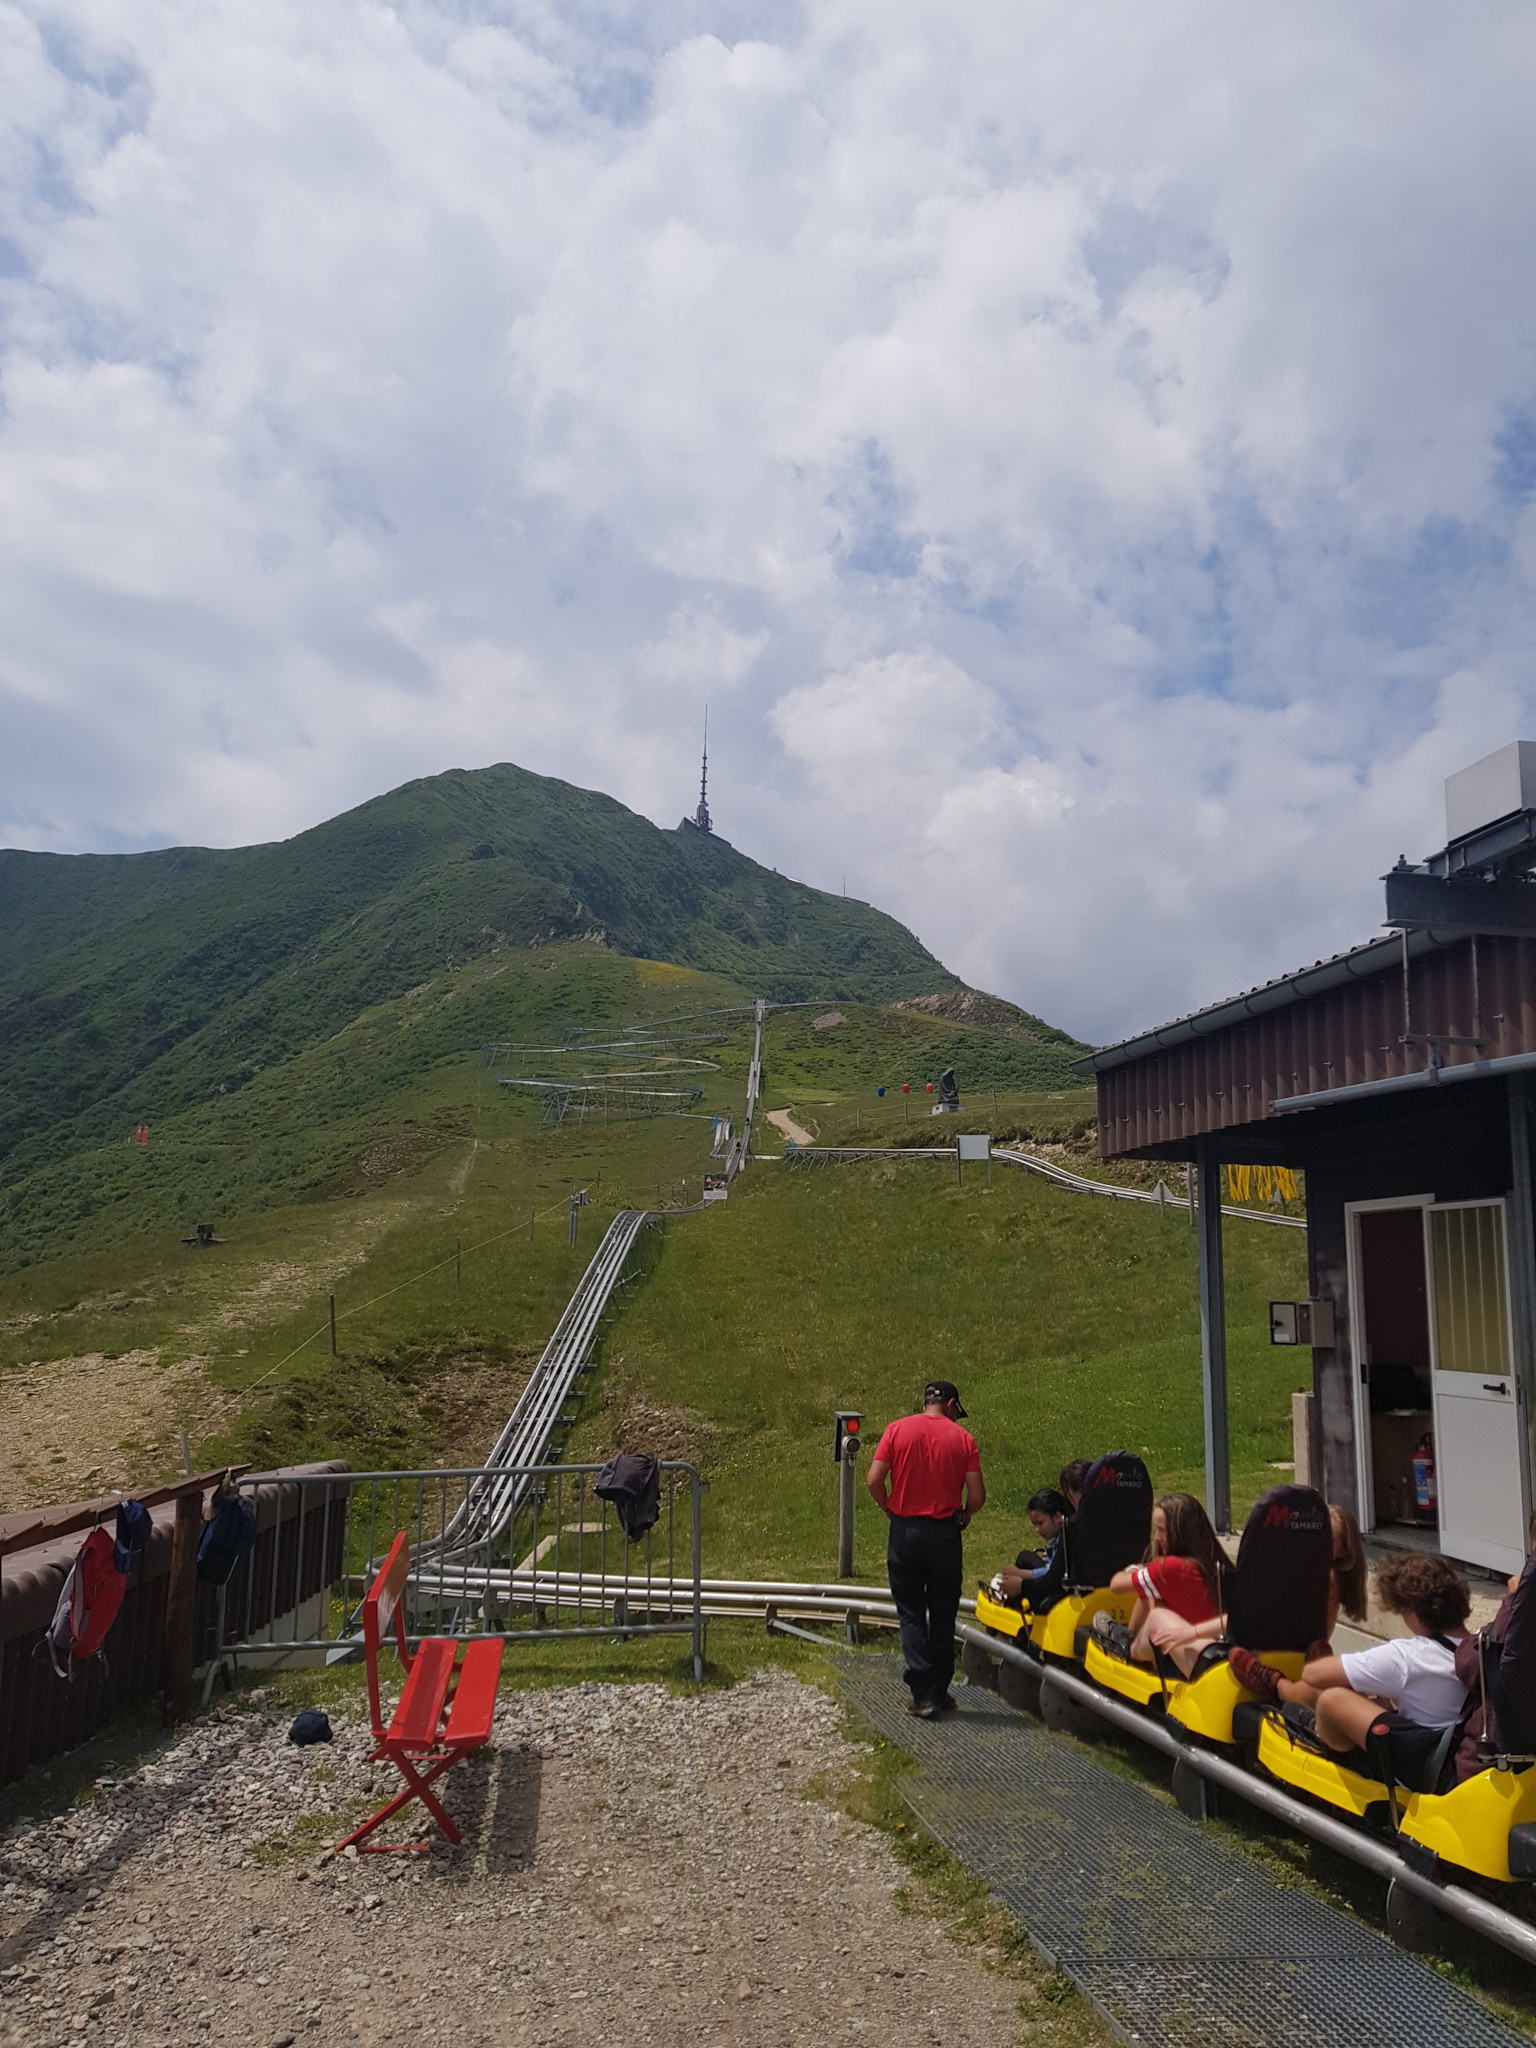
<box><xmin>217</xmin><ymin>1460</ymin><xmax>707</xmax><ymax>1677</ymax></box>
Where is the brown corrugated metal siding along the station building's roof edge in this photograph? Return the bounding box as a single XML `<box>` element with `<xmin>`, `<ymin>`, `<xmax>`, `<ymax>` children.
<box><xmin>1098</xmin><ymin>938</ymin><xmax>1536</xmax><ymax>1159</ymax></box>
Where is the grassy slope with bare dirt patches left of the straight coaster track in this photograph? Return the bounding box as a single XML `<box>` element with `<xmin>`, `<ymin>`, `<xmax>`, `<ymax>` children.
<box><xmin>0</xmin><ymin>942</ymin><xmax>1105</xmax><ymax>1497</ymax></box>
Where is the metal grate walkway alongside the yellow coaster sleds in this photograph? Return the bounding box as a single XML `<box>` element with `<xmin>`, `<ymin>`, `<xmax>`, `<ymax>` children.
<box><xmin>842</xmin><ymin>1655</ymin><xmax>1530</xmax><ymax>2048</ymax></box>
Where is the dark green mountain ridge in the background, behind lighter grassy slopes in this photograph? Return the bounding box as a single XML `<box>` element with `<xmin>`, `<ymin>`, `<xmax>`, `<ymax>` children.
<box><xmin>0</xmin><ymin>762</ymin><xmax>1077</xmax><ymax>1178</ymax></box>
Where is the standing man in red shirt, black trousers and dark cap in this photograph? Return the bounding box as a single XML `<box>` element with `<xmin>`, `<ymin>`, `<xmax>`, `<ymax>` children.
<box><xmin>864</xmin><ymin>1380</ymin><xmax>987</xmax><ymax>1720</ymax></box>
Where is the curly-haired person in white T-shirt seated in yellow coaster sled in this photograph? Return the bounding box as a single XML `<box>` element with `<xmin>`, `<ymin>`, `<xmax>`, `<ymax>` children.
<box><xmin>1292</xmin><ymin>1550</ymin><xmax>1473</xmax><ymax>1792</ymax></box>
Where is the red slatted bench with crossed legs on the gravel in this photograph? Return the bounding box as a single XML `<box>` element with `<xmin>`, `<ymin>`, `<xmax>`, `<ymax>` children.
<box><xmin>338</xmin><ymin>1530</ymin><xmax>504</xmax><ymax>1851</ymax></box>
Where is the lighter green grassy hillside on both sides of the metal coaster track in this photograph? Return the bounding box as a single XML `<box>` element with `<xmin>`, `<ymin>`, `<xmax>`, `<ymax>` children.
<box><xmin>0</xmin><ymin>946</ymin><xmax>1303</xmax><ymax>1575</ymax></box>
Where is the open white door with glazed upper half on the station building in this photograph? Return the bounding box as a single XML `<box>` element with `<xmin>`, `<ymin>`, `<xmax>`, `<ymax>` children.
<box><xmin>1425</xmin><ymin>1202</ymin><xmax>1526</xmax><ymax>1571</ymax></box>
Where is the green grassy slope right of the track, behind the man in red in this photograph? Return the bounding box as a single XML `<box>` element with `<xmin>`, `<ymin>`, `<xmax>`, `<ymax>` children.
<box><xmin>573</xmin><ymin>1161</ymin><xmax>1303</xmax><ymax>1577</ymax></box>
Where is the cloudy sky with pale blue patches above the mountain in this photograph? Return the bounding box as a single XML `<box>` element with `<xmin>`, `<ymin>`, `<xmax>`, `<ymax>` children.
<box><xmin>0</xmin><ymin>0</ymin><xmax>1536</xmax><ymax>1040</ymax></box>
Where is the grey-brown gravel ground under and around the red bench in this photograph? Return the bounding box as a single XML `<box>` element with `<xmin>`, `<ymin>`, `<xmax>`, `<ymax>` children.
<box><xmin>0</xmin><ymin>1671</ymin><xmax>1034</xmax><ymax>2048</ymax></box>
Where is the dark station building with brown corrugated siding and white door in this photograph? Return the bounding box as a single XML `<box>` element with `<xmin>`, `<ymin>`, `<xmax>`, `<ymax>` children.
<box><xmin>1083</xmin><ymin>741</ymin><xmax>1536</xmax><ymax>1573</ymax></box>
